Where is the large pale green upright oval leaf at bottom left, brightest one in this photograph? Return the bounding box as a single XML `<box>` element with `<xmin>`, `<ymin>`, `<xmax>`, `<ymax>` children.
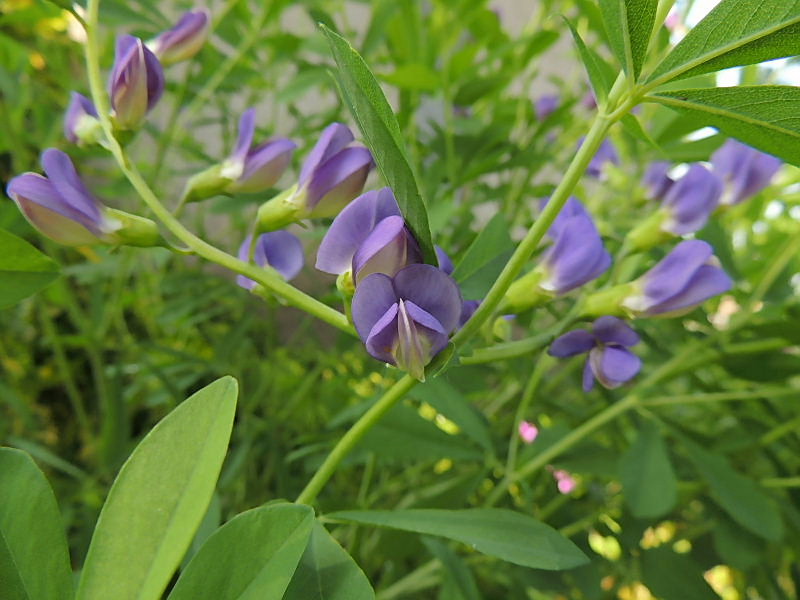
<box><xmin>77</xmin><ymin>377</ymin><xmax>237</xmax><ymax>600</ymax></box>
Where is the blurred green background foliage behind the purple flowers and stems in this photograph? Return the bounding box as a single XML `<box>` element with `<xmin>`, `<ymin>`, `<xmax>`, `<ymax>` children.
<box><xmin>0</xmin><ymin>0</ymin><xmax>800</xmax><ymax>600</ymax></box>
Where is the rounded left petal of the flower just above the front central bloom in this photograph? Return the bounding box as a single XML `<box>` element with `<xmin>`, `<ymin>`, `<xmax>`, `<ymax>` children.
<box><xmin>316</xmin><ymin>187</ymin><xmax>400</xmax><ymax>275</ymax></box>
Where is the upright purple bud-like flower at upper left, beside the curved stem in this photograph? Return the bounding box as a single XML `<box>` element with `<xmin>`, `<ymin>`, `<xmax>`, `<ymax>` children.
<box><xmin>109</xmin><ymin>35</ymin><xmax>164</xmax><ymax>129</ymax></box>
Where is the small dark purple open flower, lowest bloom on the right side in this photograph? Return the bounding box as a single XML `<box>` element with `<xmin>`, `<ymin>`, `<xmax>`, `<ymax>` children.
<box><xmin>547</xmin><ymin>317</ymin><xmax>642</xmax><ymax>392</ymax></box>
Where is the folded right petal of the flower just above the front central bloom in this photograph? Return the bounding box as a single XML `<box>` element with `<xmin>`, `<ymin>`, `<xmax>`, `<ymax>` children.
<box><xmin>352</xmin><ymin>216</ymin><xmax>422</xmax><ymax>285</ymax></box>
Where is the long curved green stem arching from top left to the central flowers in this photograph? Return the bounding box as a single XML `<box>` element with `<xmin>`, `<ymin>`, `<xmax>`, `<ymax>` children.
<box><xmin>86</xmin><ymin>0</ymin><xmax>356</xmax><ymax>336</ymax></box>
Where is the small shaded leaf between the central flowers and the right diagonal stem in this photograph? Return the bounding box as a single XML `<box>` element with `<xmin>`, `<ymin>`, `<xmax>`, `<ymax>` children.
<box><xmin>453</xmin><ymin>213</ymin><xmax>514</xmax><ymax>299</ymax></box>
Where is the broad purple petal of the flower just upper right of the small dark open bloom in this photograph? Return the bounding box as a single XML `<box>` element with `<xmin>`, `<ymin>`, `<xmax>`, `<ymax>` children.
<box><xmin>643</xmin><ymin>240</ymin><xmax>714</xmax><ymax>308</ymax></box>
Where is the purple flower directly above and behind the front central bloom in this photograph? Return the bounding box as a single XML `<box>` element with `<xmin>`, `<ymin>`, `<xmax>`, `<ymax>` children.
<box><xmin>316</xmin><ymin>187</ymin><xmax>422</xmax><ymax>284</ymax></box>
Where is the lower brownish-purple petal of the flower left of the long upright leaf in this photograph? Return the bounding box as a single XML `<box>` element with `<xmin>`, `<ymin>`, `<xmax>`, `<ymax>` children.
<box><xmin>307</xmin><ymin>146</ymin><xmax>373</xmax><ymax>217</ymax></box>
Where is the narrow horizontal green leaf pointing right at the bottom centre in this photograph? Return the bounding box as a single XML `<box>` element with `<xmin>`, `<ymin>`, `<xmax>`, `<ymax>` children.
<box><xmin>326</xmin><ymin>508</ymin><xmax>587</xmax><ymax>571</ymax></box>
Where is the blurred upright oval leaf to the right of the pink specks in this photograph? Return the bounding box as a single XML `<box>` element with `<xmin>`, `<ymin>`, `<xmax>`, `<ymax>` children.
<box><xmin>619</xmin><ymin>423</ymin><xmax>678</xmax><ymax>519</ymax></box>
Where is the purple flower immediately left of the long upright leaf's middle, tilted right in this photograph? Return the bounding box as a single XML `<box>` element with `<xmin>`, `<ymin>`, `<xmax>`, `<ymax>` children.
<box><xmin>298</xmin><ymin>123</ymin><xmax>374</xmax><ymax>217</ymax></box>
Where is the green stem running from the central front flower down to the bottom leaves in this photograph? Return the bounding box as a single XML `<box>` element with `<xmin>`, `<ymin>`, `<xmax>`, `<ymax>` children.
<box><xmin>295</xmin><ymin>375</ymin><xmax>418</xmax><ymax>504</ymax></box>
